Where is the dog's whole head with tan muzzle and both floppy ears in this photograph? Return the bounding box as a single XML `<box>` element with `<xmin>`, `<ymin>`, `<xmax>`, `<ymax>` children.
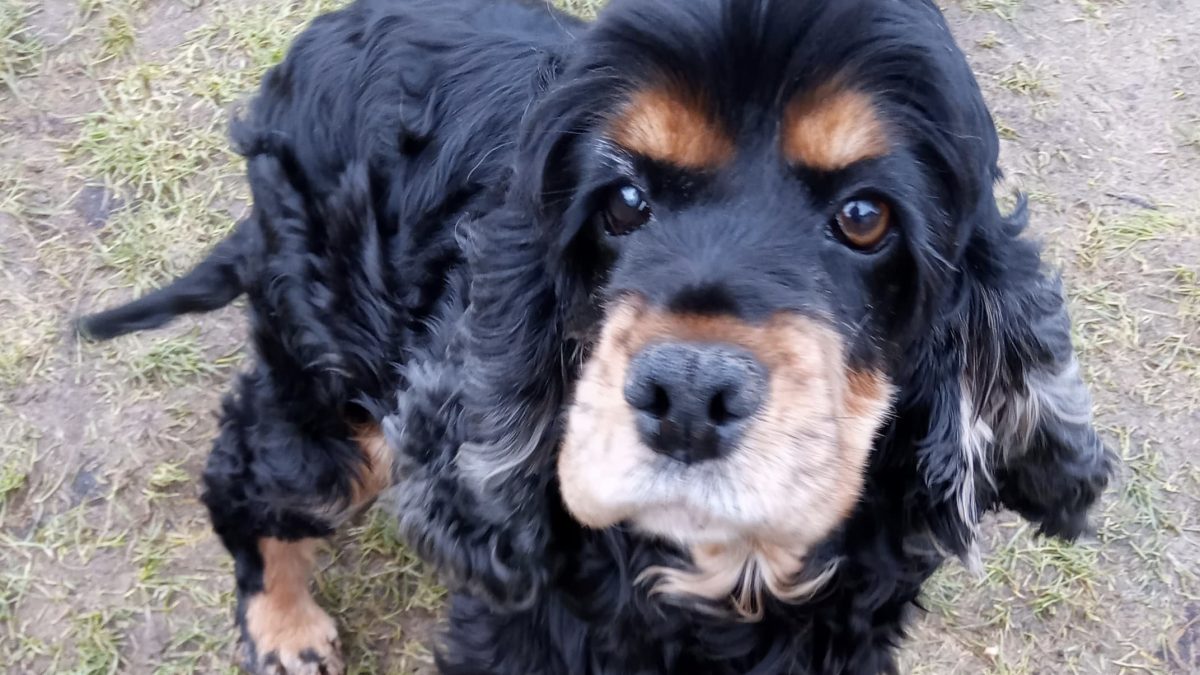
<box><xmin>463</xmin><ymin>0</ymin><xmax>1106</xmax><ymax>612</ymax></box>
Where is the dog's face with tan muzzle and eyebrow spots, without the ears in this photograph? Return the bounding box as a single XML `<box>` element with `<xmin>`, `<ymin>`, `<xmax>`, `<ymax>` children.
<box><xmin>547</xmin><ymin>0</ymin><xmax>994</xmax><ymax>605</ymax></box>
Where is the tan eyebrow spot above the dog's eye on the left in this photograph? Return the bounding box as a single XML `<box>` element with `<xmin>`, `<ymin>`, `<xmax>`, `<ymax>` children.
<box><xmin>610</xmin><ymin>88</ymin><xmax>733</xmax><ymax>169</ymax></box>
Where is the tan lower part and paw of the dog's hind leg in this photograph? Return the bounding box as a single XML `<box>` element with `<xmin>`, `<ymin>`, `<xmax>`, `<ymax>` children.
<box><xmin>245</xmin><ymin>538</ymin><xmax>343</xmax><ymax>675</ymax></box>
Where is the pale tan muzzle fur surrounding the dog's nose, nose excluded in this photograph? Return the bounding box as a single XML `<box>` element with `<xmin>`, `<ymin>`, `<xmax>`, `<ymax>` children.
<box><xmin>558</xmin><ymin>300</ymin><xmax>892</xmax><ymax>615</ymax></box>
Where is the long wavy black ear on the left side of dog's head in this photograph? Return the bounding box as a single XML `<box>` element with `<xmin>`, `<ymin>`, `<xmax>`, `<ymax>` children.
<box><xmin>384</xmin><ymin>51</ymin><xmax>600</xmax><ymax>608</ymax></box>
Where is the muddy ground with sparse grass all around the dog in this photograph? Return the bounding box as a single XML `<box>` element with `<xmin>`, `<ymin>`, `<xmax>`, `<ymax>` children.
<box><xmin>0</xmin><ymin>0</ymin><xmax>1200</xmax><ymax>675</ymax></box>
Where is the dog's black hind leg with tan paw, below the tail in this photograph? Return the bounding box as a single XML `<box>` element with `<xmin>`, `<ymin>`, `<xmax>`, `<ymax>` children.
<box><xmin>204</xmin><ymin>377</ymin><xmax>392</xmax><ymax>675</ymax></box>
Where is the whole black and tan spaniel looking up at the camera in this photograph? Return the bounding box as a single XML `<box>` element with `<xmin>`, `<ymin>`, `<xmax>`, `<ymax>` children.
<box><xmin>80</xmin><ymin>0</ymin><xmax>1115</xmax><ymax>675</ymax></box>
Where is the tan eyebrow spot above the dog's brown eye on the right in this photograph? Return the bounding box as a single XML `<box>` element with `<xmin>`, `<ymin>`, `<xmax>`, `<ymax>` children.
<box><xmin>782</xmin><ymin>85</ymin><xmax>889</xmax><ymax>171</ymax></box>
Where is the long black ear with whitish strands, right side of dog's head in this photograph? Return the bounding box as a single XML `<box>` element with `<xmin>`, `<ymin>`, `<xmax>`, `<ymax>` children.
<box><xmin>892</xmin><ymin>9</ymin><xmax>1114</xmax><ymax>555</ymax></box>
